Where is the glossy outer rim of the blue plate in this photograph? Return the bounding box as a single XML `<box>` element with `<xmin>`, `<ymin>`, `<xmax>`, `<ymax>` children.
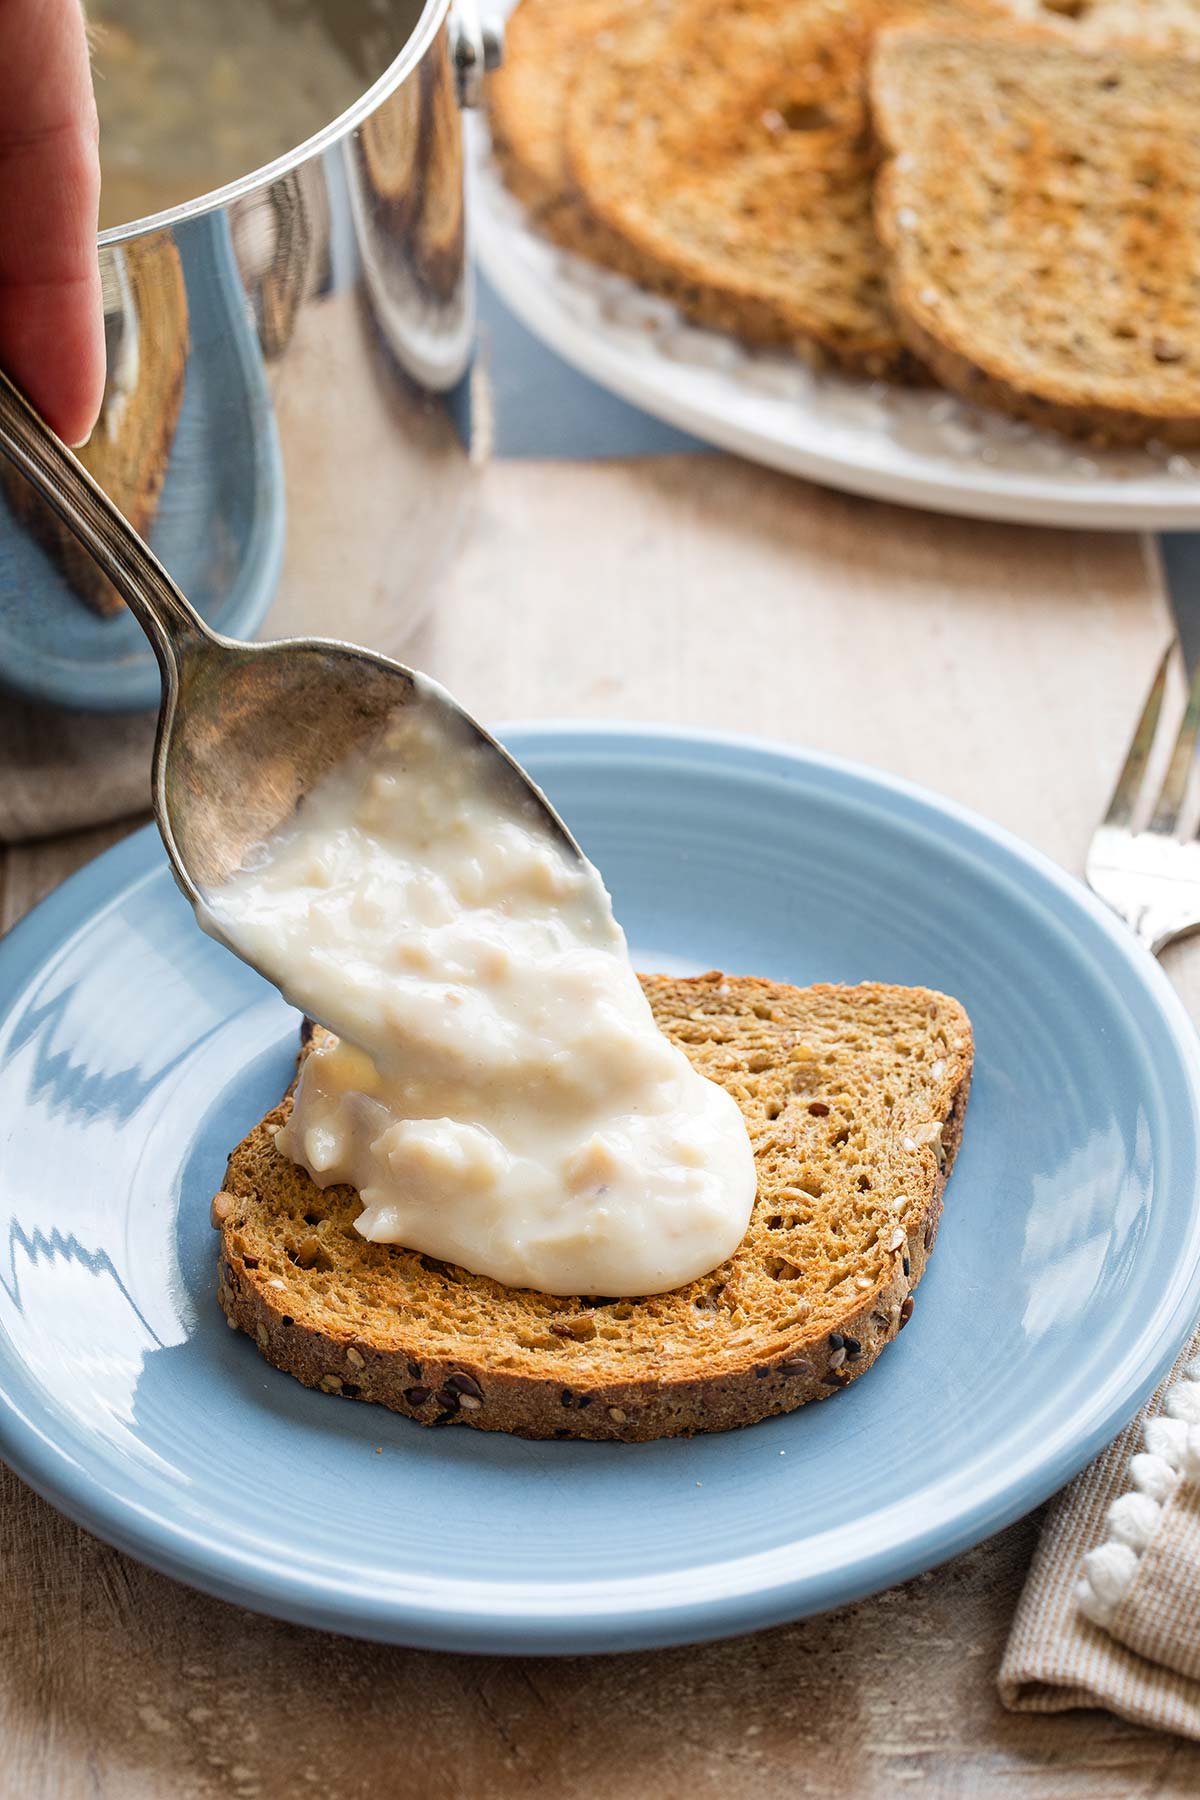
<box><xmin>0</xmin><ymin>720</ymin><xmax>1200</xmax><ymax>1654</ymax></box>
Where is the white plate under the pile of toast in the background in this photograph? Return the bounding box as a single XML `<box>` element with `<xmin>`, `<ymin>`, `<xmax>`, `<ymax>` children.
<box><xmin>473</xmin><ymin>121</ymin><xmax>1200</xmax><ymax>531</ymax></box>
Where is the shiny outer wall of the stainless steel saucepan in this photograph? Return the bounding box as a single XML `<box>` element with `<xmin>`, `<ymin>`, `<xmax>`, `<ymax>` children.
<box><xmin>0</xmin><ymin>0</ymin><xmax>498</xmax><ymax>709</ymax></box>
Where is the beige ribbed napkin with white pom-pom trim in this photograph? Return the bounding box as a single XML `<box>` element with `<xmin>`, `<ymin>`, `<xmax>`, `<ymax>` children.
<box><xmin>1000</xmin><ymin>1330</ymin><xmax>1200</xmax><ymax>1739</ymax></box>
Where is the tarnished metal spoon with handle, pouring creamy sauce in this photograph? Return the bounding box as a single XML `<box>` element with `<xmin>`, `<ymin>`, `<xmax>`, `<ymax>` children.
<box><xmin>0</xmin><ymin>373</ymin><xmax>583</xmax><ymax>905</ymax></box>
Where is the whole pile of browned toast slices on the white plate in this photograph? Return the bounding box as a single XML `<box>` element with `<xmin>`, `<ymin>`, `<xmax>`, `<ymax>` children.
<box><xmin>489</xmin><ymin>0</ymin><xmax>1200</xmax><ymax>446</ymax></box>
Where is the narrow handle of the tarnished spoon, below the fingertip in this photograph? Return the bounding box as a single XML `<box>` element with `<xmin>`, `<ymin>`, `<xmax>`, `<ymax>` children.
<box><xmin>0</xmin><ymin>371</ymin><xmax>214</xmax><ymax>680</ymax></box>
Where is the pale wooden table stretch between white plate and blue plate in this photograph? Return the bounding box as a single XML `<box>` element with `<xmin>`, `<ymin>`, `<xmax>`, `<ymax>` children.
<box><xmin>414</xmin><ymin>455</ymin><xmax>1171</xmax><ymax>868</ymax></box>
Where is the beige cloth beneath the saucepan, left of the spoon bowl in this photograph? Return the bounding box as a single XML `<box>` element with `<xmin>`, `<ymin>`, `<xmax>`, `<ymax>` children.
<box><xmin>0</xmin><ymin>689</ymin><xmax>155</xmax><ymax>844</ymax></box>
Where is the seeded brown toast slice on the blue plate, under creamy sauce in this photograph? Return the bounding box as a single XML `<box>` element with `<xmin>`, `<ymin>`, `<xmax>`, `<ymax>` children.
<box><xmin>212</xmin><ymin>974</ymin><xmax>972</xmax><ymax>1440</ymax></box>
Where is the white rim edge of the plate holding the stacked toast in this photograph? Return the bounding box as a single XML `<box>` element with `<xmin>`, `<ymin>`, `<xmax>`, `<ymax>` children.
<box><xmin>468</xmin><ymin>156</ymin><xmax>1200</xmax><ymax>531</ymax></box>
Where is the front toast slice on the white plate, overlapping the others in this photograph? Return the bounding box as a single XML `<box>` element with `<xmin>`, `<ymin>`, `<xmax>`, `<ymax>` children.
<box><xmin>871</xmin><ymin>25</ymin><xmax>1200</xmax><ymax>445</ymax></box>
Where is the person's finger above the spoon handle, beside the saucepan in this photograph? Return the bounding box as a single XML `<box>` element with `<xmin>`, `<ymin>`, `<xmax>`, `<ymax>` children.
<box><xmin>0</xmin><ymin>0</ymin><xmax>104</xmax><ymax>445</ymax></box>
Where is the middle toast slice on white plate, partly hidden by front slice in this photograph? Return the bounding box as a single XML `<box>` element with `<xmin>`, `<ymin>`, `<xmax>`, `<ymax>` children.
<box><xmin>567</xmin><ymin>0</ymin><xmax>1014</xmax><ymax>378</ymax></box>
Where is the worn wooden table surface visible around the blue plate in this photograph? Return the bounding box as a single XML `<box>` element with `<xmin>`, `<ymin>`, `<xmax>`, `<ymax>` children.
<box><xmin>0</xmin><ymin>457</ymin><xmax>1200</xmax><ymax>1800</ymax></box>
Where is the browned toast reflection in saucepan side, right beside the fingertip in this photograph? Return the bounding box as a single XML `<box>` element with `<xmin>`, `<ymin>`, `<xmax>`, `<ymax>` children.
<box><xmin>0</xmin><ymin>232</ymin><xmax>189</xmax><ymax>616</ymax></box>
